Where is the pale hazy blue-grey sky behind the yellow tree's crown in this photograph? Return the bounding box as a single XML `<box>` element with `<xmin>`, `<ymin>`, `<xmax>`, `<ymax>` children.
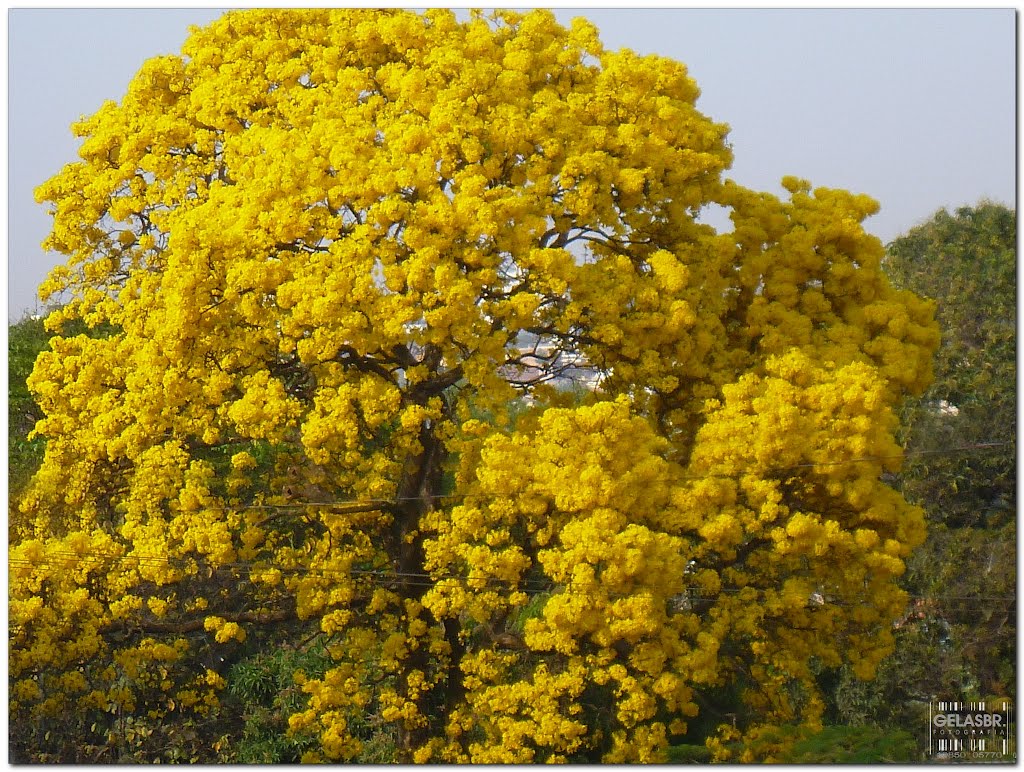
<box><xmin>8</xmin><ymin>8</ymin><xmax>1017</xmax><ymax>319</ymax></box>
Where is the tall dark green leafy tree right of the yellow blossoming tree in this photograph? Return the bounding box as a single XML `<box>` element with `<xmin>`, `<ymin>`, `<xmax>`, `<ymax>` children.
<box><xmin>835</xmin><ymin>203</ymin><xmax>1017</xmax><ymax>741</ymax></box>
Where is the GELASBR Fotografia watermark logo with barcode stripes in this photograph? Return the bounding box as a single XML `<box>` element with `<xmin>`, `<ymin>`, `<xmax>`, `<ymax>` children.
<box><xmin>928</xmin><ymin>700</ymin><xmax>1017</xmax><ymax>761</ymax></box>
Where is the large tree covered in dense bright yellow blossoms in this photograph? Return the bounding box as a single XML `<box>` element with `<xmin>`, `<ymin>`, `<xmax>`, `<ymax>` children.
<box><xmin>9</xmin><ymin>9</ymin><xmax>937</xmax><ymax>763</ymax></box>
